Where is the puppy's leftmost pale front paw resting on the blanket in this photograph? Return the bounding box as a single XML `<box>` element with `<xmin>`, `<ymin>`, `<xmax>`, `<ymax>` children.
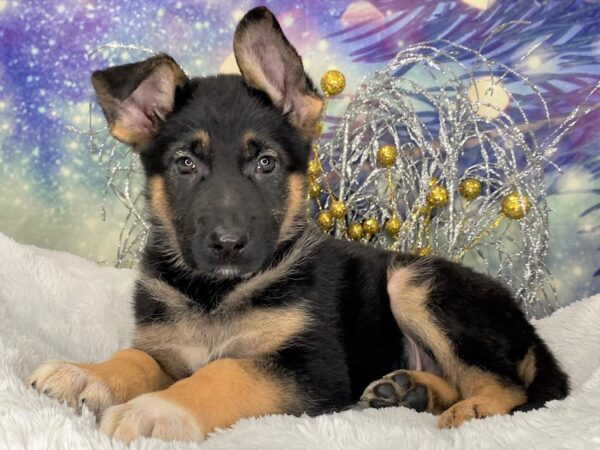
<box><xmin>26</xmin><ymin>361</ymin><xmax>115</xmax><ymax>416</ymax></box>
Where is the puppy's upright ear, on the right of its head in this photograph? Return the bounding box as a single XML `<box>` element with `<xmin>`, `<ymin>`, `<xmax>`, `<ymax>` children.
<box><xmin>233</xmin><ymin>6</ymin><xmax>323</xmax><ymax>135</ymax></box>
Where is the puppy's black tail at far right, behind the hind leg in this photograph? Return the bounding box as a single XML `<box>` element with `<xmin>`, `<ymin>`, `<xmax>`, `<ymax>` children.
<box><xmin>513</xmin><ymin>336</ymin><xmax>569</xmax><ymax>412</ymax></box>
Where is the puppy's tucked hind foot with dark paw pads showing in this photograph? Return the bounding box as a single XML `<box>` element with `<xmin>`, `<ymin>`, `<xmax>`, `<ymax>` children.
<box><xmin>361</xmin><ymin>370</ymin><xmax>460</xmax><ymax>414</ymax></box>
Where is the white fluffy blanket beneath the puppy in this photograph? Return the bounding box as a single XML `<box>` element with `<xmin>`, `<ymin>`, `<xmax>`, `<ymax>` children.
<box><xmin>0</xmin><ymin>234</ymin><xmax>600</xmax><ymax>450</ymax></box>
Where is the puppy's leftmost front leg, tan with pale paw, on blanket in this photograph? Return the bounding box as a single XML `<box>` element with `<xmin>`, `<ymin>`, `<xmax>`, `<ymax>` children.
<box><xmin>27</xmin><ymin>349</ymin><xmax>173</xmax><ymax>416</ymax></box>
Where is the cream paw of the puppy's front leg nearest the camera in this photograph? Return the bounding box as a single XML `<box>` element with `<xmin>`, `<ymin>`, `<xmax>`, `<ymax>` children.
<box><xmin>100</xmin><ymin>393</ymin><xmax>204</xmax><ymax>442</ymax></box>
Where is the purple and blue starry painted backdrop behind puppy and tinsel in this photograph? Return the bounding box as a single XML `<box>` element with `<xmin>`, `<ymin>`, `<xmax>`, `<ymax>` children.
<box><xmin>0</xmin><ymin>0</ymin><xmax>600</xmax><ymax>303</ymax></box>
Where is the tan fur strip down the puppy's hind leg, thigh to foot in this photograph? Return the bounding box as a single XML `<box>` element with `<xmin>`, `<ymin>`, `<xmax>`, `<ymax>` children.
<box><xmin>388</xmin><ymin>259</ymin><xmax>527</xmax><ymax>428</ymax></box>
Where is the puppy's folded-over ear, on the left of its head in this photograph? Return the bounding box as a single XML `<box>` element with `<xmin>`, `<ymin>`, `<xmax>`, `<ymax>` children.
<box><xmin>92</xmin><ymin>55</ymin><xmax>187</xmax><ymax>147</ymax></box>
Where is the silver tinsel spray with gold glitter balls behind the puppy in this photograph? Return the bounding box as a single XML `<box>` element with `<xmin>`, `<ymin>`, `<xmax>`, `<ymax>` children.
<box><xmin>72</xmin><ymin>34</ymin><xmax>587</xmax><ymax>316</ymax></box>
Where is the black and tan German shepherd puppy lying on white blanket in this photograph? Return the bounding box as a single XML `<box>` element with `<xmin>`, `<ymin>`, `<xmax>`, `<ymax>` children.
<box><xmin>29</xmin><ymin>7</ymin><xmax>569</xmax><ymax>441</ymax></box>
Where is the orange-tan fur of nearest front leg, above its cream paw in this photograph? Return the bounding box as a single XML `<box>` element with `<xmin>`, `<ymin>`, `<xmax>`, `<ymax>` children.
<box><xmin>157</xmin><ymin>359</ymin><xmax>299</xmax><ymax>433</ymax></box>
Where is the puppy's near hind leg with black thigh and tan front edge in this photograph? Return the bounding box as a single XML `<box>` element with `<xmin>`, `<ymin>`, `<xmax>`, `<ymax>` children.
<box><xmin>388</xmin><ymin>260</ymin><xmax>533</xmax><ymax>428</ymax></box>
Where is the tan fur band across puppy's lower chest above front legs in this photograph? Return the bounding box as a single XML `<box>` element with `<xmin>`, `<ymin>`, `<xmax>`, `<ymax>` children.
<box><xmin>134</xmin><ymin>306</ymin><xmax>309</xmax><ymax>379</ymax></box>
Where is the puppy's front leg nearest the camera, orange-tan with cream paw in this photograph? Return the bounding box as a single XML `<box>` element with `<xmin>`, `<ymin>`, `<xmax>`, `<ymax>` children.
<box><xmin>101</xmin><ymin>359</ymin><xmax>300</xmax><ymax>442</ymax></box>
